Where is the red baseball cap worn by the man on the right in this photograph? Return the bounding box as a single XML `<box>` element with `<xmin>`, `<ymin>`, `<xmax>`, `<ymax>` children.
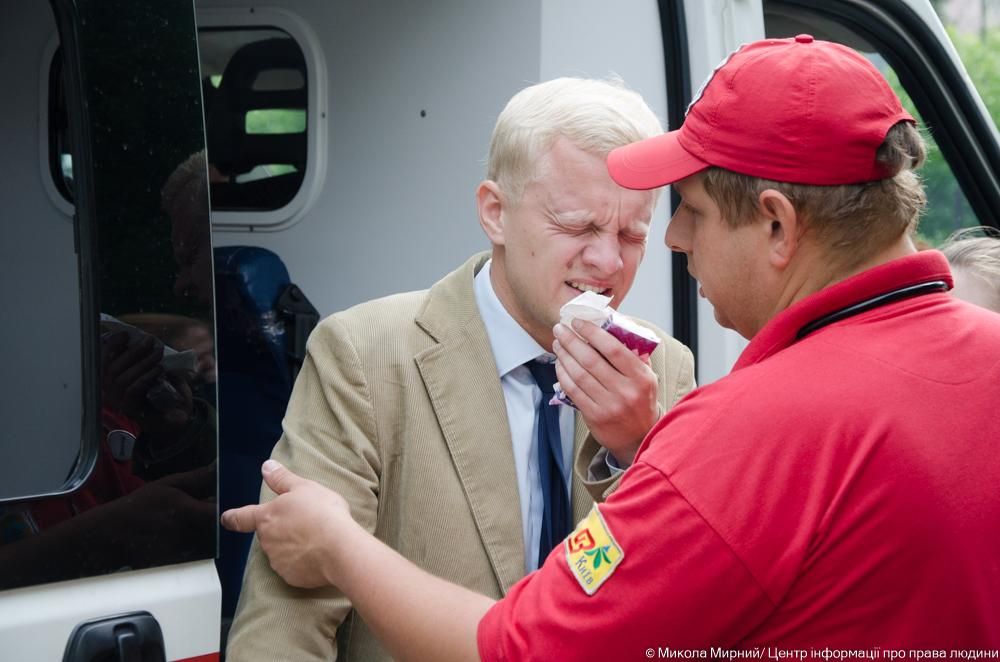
<box><xmin>608</xmin><ymin>34</ymin><xmax>914</xmax><ymax>189</ymax></box>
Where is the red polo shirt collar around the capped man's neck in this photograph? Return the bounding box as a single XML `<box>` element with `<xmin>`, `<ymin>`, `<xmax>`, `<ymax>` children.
<box><xmin>733</xmin><ymin>250</ymin><xmax>952</xmax><ymax>371</ymax></box>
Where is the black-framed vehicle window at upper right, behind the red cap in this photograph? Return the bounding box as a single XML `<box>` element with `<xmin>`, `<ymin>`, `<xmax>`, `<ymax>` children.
<box><xmin>764</xmin><ymin>0</ymin><xmax>1000</xmax><ymax>247</ymax></box>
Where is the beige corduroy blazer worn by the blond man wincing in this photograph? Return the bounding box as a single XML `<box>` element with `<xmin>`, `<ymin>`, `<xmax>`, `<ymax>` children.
<box><xmin>227</xmin><ymin>254</ymin><xmax>693</xmax><ymax>662</ymax></box>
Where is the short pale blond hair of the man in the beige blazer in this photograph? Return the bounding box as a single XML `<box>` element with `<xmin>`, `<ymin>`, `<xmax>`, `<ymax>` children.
<box><xmin>486</xmin><ymin>78</ymin><xmax>663</xmax><ymax>205</ymax></box>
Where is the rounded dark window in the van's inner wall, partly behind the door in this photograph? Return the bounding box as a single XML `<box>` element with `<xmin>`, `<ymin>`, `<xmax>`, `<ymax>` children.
<box><xmin>46</xmin><ymin>21</ymin><xmax>315</xmax><ymax>226</ymax></box>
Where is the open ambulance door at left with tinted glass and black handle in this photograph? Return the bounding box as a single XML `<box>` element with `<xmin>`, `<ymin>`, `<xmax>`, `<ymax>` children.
<box><xmin>0</xmin><ymin>0</ymin><xmax>220</xmax><ymax>660</ymax></box>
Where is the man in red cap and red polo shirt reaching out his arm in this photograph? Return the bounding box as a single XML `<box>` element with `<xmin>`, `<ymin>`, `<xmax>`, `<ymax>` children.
<box><xmin>224</xmin><ymin>35</ymin><xmax>1000</xmax><ymax>660</ymax></box>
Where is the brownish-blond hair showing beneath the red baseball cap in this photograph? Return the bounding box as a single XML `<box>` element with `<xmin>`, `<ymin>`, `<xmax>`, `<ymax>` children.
<box><xmin>703</xmin><ymin>122</ymin><xmax>927</xmax><ymax>269</ymax></box>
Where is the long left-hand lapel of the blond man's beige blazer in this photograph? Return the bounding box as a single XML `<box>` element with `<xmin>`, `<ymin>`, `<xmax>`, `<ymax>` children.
<box><xmin>415</xmin><ymin>255</ymin><xmax>524</xmax><ymax>587</ymax></box>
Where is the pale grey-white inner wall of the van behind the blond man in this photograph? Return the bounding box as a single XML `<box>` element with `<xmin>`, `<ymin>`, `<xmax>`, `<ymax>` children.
<box><xmin>205</xmin><ymin>0</ymin><xmax>696</xmax><ymax>374</ymax></box>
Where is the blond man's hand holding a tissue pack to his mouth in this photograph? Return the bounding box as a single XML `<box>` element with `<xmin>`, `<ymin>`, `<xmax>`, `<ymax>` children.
<box><xmin>552</xmin><ymin>320</ymin><xmax>660</xmax><ymax>468</ymax></box>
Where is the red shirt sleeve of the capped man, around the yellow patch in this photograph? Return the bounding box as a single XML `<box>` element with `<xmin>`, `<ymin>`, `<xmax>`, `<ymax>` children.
<box><xmin>477</xmin><ymin>461</ymin><xmax>773</xmax><ymax>661</ymax></box>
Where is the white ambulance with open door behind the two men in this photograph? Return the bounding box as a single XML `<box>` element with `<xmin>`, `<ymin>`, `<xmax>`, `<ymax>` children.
<box><xmin>0</xmin><ymin>0</ymin><xmax>1000</xmax><ymax>662</ymax></box>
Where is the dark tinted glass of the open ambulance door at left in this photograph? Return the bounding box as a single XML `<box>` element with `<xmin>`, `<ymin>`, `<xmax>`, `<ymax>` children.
<box><xmin>0</xmin><ymin>0</ymin><xmax>217</xmax><ymax>589</ymax></box>
